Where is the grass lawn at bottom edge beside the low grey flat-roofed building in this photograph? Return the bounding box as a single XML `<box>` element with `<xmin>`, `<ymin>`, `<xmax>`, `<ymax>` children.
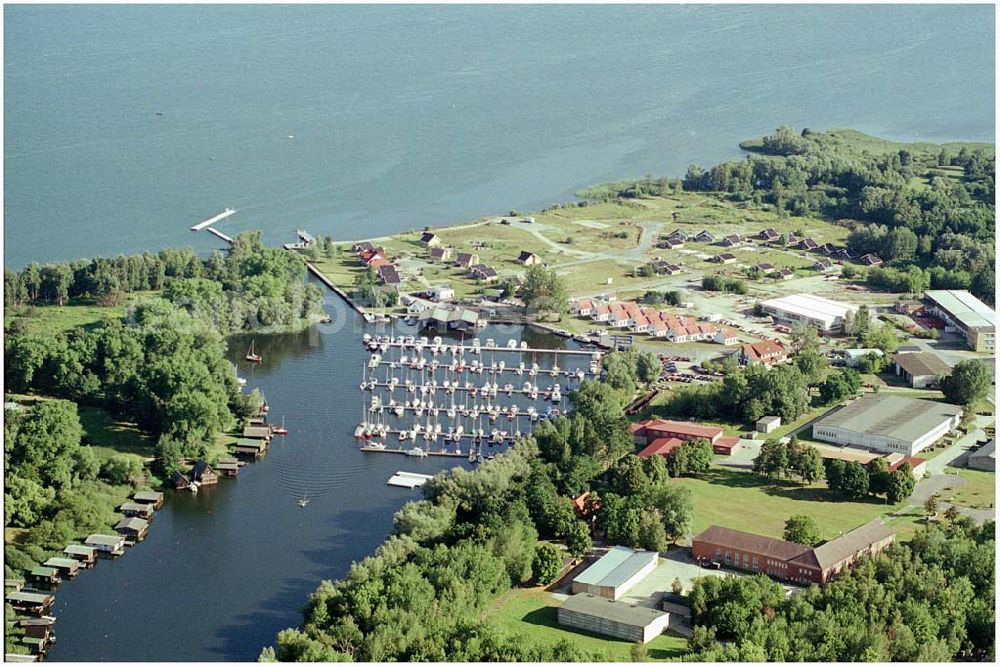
<box><xmin>485</xmin><ymin>588</ymin><xmax>687</xmax><ymax>662</ymax></box>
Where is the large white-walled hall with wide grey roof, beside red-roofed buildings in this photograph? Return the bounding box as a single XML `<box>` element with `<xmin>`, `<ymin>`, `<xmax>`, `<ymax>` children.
<box><xmin>813</xmin><ymin>394</ymin><xmax>962</xmax><ymax>456</ymax></box>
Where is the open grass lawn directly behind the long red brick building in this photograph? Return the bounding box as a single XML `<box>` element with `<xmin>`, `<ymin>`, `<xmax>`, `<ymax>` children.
<box><xmin>671</xmin><ymin>466</ymin><xmax>893</xmax><ymax>540</ymax></box>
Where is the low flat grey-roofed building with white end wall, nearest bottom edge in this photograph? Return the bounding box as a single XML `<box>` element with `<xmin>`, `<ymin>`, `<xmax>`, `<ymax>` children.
<box><xmin>558</xmin><ymin>593</ymin><xmax>670</xmax><ymax>644</ymax></box>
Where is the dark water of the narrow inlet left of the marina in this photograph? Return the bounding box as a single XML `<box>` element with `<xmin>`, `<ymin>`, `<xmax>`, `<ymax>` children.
<box><xmin>43</xmin><ymin>288</ymin><xmax>584</xmax><ymax>661</ymax></box>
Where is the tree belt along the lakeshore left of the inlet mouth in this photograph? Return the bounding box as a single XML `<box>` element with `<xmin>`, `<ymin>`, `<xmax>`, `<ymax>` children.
<box><xmin>4</xmin><ymin>231</ymin><xmax>323</xmax><ymax>334</ymax></box>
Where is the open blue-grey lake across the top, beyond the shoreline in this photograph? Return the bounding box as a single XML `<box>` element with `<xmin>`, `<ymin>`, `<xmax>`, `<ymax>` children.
<box><xmin>4</xmin><ymin>6</ymin><xmax>994</xmax><ymax>266</ymax></box>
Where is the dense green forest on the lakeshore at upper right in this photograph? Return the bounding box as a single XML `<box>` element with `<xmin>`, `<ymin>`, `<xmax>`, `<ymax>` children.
<box><xmin>581</xmin><ymin>127</ymin><xmax>996</xmax><ymax>303</ymax></box>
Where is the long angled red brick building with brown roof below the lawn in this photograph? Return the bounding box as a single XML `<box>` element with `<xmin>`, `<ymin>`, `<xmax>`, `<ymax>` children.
<box><xmin>691</xmin><ymin>519</ymin><xmax>896</xmax><ymax>584</ymax></box>
